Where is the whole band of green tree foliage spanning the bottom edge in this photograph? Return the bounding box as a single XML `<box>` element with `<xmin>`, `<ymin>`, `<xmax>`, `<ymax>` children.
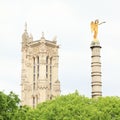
<box><xmin>0</xmin><ymin>91</ymin><xmax>120</xmax><ymax>120</ymax></box>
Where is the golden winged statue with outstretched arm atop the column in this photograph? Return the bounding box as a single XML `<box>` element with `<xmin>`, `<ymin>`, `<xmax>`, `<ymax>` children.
<box><xmin>90</xmin><ymin>19</ymin><xmax>105</xmax><ymax>41</ymax></box>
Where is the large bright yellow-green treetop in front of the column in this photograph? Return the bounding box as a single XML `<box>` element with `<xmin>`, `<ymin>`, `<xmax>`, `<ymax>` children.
<box><xmin>33</xmin><ymin>92</ymin><xmax>120</xmax><ymax>120</ymax></box>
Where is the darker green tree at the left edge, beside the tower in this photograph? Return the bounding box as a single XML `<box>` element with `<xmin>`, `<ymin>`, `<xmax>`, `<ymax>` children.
<box><xmin>0</xmin><ymin>92</ymin><xmax>20</xmax><ymax>120</ymax></box>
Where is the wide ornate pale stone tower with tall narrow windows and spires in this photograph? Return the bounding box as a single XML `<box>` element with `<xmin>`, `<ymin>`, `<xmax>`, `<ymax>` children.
<box><xmin>21</xmin><ymin>24</ymin><xmax>60</xmax><ymax>108</ymax></box>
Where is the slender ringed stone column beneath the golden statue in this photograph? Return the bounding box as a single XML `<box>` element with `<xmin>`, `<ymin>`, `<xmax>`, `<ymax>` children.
<box><xmin>90</xmin><ymin>41</ymin><xmax>102</xmax><ymax>98</ymax></box>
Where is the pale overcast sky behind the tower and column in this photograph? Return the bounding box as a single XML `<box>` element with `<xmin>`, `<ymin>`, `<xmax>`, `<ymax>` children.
<box><xmin>0</xmin><ymin>0</ymin><xmax>120</xmax><ymax>97</ymax></box>
